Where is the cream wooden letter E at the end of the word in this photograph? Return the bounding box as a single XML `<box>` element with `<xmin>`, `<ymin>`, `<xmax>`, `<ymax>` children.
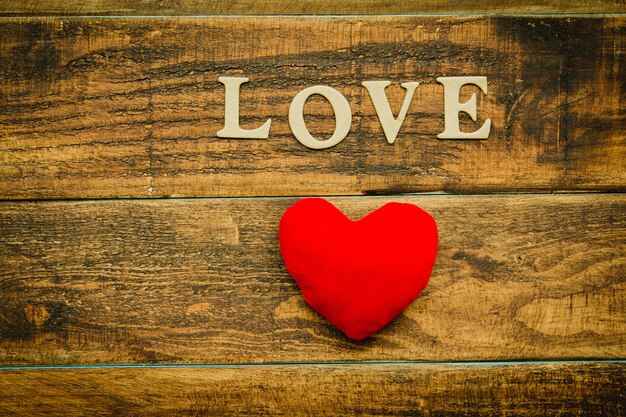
<box><xmin>437</xmin><ymin>77</ymin><xmax>491</xmax><ymax>139</ymax></box>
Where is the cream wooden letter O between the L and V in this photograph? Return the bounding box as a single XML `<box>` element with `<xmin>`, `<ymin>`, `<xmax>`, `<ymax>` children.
<box><xmin>289</xmin><ymin>85</ymin><xmax>352</xmax><ymax>149</ymax></box>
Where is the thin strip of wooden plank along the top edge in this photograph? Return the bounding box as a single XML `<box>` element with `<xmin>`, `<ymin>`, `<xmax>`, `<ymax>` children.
<box><xmin>0</xmin><ymin>0</ymin><xmax>626</xmax><ymax>16</ymax></box>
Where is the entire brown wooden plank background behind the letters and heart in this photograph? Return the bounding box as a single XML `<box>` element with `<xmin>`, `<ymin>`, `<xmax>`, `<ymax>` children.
<box><xmin>0</xmin><ymin>0</ymin><xmax>626</xmax><ymax>416</ymax></box>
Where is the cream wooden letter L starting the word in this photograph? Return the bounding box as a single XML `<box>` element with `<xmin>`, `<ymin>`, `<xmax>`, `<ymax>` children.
<box><xmin>217</xmin><ymin>77</ymin><xmax>272</xmax><ymax>139</ymax></box>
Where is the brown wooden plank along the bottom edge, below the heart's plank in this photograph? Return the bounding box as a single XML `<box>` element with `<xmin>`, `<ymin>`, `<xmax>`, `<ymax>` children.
<box><xmin>0</xmin><ymin>363</ymin><xmax>626</xmax><ymax>417</ymax></box>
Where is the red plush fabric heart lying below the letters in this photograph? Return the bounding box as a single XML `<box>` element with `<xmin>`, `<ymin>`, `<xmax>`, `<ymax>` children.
<box><xmin>279</xmin><ymin>198</ymin><xmax>438</xmax><ymax>340</ymax></box>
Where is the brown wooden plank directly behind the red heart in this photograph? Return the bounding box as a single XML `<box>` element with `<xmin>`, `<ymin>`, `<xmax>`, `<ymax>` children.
<box><xmin>0</xmin><ymin>194</ymin><xmax>626</xmax><ymax>364</ymax></box>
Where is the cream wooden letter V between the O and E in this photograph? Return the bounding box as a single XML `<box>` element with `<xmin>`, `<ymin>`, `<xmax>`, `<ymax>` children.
<box><xmin>361</xmin><ymin>81</ymin><xmax>419</xmax><ymax>143</ymax></box>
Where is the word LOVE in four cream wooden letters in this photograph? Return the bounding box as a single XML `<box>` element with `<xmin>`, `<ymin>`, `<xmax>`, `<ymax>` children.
<box><xmin>217</xmin><ymin>76</ymin><xmax>491</xmax><ymax>149</ymax></box>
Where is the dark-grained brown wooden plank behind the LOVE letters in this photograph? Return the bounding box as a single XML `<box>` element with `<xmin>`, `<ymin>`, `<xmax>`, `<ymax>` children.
<box><xmin>0</xmin><ymin>16</ymin><xmax>626</xmax><ymax>199</ymax></box>
